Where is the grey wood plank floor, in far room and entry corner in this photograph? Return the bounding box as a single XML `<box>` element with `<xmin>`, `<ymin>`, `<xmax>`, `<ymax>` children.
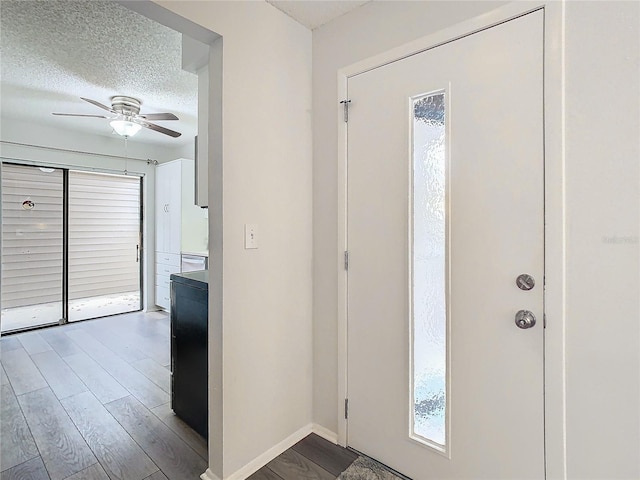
<box><xmin>0</xmin><ymin>312</ymin><xmax>357</xmax><ymax>480</ymax></box>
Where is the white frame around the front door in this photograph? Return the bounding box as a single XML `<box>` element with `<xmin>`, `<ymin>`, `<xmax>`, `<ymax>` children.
<box><xmin>336</xmin><ymin>0</ymin><xmax>567</xmax><ymax>480</ymax></box>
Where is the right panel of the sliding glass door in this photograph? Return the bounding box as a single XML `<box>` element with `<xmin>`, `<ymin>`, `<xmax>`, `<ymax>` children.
<box><xmin>69</xmin><ymin>171</ymin><xmax>141</xmax><ymax>322</ymax></box>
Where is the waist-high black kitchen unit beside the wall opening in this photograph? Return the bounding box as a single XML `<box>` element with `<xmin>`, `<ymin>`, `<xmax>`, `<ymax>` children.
<box><xmin>170</xmin><ymin>270</ymin><xmax>209</xmax><ymax>438</ymax></box>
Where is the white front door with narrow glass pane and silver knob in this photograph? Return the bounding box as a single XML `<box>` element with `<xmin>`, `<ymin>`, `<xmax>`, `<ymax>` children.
<box><xmin>347</xmin><ymin>11</ymin><xmax>544</xmax><ymax>480</ymax></box>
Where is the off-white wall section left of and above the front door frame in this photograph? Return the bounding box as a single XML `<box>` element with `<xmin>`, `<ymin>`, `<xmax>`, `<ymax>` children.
<box><xmin>313</xmin><ymin>1</ymin><xmax>506</xmax><ymax>432</ymax></box>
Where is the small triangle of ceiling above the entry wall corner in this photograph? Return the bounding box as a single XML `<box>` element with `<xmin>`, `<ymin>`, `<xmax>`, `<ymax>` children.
<box><xmin>267</xmin><ymin>0</ymin><xmax>370</xmax><ymax>30</ymax></box>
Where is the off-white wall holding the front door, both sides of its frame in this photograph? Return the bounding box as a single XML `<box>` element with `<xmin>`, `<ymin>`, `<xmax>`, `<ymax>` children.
<box><xmin>313</xmin><ymin>1</ymin><xmax>640</xmax><ymax>480</ymax></box>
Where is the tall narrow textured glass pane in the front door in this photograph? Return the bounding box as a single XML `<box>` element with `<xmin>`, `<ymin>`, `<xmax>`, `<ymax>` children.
<box><xmin>412</xmin><ymin>92</ymin><xmax>447</xmax><ymax>446</ymax></box>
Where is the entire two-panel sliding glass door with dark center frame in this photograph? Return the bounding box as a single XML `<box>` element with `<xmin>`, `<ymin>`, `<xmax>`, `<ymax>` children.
<box><xmin>0</xmin><ymin>163</ymin><xmax>142</xmax><ymax>333</ymax></box>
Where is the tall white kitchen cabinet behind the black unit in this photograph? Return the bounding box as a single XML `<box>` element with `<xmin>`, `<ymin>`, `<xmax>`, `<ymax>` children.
<box><xmin>155</xmin><ymin>159</ymin><xmax>208</xmax><ymax>310</ymax></box>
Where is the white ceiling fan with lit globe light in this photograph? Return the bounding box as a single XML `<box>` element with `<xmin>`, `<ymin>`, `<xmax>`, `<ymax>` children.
<box><xmin>53</xmin><ymin>95</ymin><xmax>182</xmax><ymax>138</ymax></box>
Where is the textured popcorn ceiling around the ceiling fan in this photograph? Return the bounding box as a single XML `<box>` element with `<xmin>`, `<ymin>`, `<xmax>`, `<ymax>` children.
<box><xmin>0</xmin><ymin>0</ymin><xmax>197</xmax><ymax>145</ymax></box>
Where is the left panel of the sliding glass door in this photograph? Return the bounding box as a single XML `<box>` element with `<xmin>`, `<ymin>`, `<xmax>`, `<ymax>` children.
<box><xmin>0</xmin><ymin>164</ymin><xmax>65</xmax><ymax>332</ymax></box>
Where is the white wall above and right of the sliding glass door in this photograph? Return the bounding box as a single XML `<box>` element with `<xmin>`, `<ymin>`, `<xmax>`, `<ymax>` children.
<box><xmin>0</xmin><ymin>117</ymin><xmax>186</xmax><ymax>310</ymax></box>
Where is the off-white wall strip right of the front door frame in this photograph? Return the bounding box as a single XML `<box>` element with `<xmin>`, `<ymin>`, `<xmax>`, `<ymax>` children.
<box><xmin>566</xmin><ymin>1</ymin><xmax>640</xmax><ymax>479</ymax></box>
